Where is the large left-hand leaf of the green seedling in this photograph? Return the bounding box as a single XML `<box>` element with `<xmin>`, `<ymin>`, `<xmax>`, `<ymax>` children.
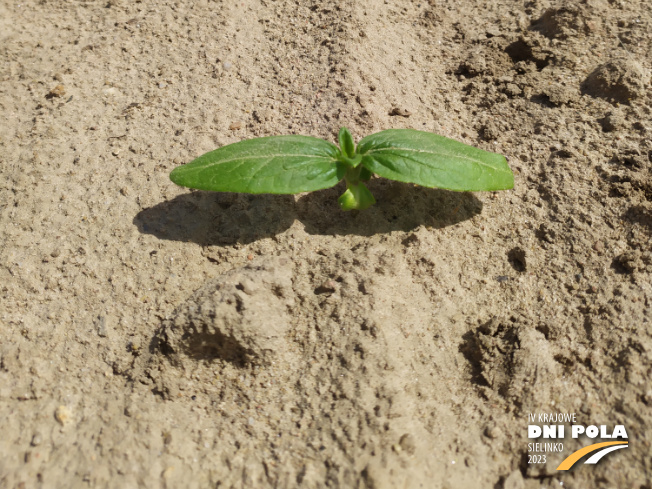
<box><xmin>170</xmin><ymin>136</ymin><xmax>346</xmax><ymax>194</ymax></box>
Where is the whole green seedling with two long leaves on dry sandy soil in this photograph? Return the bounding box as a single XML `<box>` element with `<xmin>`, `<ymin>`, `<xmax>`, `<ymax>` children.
<box><xmin>170</xmin><ymin>127</ymin><xmax>514</xmax><ymax>211</ymax></box>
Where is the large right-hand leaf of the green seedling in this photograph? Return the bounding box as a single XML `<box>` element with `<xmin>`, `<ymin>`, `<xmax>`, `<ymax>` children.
<box><xmin>357</xmin><ymin>129</ymin><xmax>514</xmax><ymax>192</ymax></box>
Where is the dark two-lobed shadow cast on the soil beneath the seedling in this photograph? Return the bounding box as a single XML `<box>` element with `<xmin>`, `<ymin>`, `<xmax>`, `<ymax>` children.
<box><xmin>133</xmin><ymin>179</ymin><xmax>482</xmax><ymax>246</ymax></box>
